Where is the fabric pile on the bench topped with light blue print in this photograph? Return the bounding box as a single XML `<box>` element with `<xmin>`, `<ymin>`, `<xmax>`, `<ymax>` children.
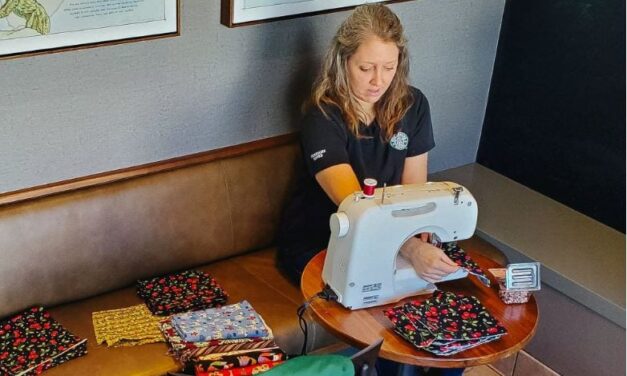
<box><xmin>161</xmin><ymin>300</ymin><xmax>285</xmax><ymax>376</ymax></box>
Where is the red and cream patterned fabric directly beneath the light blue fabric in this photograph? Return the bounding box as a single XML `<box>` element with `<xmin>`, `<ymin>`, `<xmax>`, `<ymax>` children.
<box><xmin>160</xmin><ymin>319</ymin><xmax>277</xmax><ymax>364</ymax></box>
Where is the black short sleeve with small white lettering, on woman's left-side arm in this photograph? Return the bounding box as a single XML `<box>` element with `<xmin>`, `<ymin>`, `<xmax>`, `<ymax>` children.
<box><xmin>301</xmin><ymin>108</ymin><xmax>350</xmax><ymax>176</ymax></box>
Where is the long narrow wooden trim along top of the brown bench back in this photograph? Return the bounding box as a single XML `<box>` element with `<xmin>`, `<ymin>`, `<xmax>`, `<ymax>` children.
<box><xmin>0</xmin><ymin>133</ymin><xmax>297</xmax><ymax>207</ymax></box>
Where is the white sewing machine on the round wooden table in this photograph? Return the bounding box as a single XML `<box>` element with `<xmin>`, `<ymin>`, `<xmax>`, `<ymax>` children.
<box><xmin>322</xmin><ymin>182</ymin><xmax>477</xmax><ymax>309</ymax></box>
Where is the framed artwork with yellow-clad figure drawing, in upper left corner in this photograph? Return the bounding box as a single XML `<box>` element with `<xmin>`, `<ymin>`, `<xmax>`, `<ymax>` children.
<box><xmin>0</xmin><ymin>0</ymin><xmax>179</xmax><ymax>59</ymax></box>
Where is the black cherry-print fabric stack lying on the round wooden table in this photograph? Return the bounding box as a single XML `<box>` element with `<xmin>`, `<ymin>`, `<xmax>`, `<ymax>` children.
<box><xmin>384</xmin><ymin>291</ymin><xmax>507</xmax><ymax>356</ymax></box>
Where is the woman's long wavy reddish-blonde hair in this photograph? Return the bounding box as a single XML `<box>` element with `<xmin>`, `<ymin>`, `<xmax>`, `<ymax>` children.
<box><xmin>305</xmin><ymin>4</ymin><xmax>414</xmax><ymax>142</ymax></box>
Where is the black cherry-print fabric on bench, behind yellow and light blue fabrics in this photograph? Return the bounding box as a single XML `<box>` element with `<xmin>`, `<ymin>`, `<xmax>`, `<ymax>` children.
<box><xmin>137</xmin><ymin>270</ymin><xmax>228</xmax><ymax>316</ymax></box>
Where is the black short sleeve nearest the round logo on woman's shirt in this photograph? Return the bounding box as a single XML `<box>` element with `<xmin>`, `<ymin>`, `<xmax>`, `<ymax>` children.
<box><xmin>405</xmin><ymin>89</ymin><xmax>435</xmax><ymax>157</ymax></box>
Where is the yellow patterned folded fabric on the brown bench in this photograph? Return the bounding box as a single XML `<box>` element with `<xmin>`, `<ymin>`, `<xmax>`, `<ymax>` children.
<box><xmin>91</xmin><ymin>304</ymin><xmax>165</xmax><ymax>346</ymax></box>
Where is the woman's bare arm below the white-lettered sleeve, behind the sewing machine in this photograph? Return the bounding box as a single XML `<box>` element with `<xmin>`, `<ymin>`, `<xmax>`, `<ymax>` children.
<box><xmin>315</xmin><ymin>163</ymin><xmax>361</xmax><ymax>205</ymax></box>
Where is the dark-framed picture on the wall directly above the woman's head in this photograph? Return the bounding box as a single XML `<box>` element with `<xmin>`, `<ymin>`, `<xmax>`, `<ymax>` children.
<box><xmin>220</xmin><ymin>0</ymin><xmax>411</xmax><ymax>27</ymax></box>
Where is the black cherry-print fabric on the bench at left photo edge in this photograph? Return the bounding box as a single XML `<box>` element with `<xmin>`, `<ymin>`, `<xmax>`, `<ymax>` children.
<box><xmin>0</xmin><ymin>307</ymin><xmax>87</xmax><ymax>376</ymax></box>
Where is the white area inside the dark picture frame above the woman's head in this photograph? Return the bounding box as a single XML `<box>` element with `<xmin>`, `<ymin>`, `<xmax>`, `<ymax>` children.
<box><xmin>231</xmin><ymin>0</ymin><xmax>388</xmax><ymax>24</ymax></box>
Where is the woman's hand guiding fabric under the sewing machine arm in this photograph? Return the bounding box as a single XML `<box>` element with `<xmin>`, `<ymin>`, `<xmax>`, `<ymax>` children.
<box><xmin>401</xmin><ymin>237</ymin><xmax>459</xmax><ymax>283</ymax></box>
